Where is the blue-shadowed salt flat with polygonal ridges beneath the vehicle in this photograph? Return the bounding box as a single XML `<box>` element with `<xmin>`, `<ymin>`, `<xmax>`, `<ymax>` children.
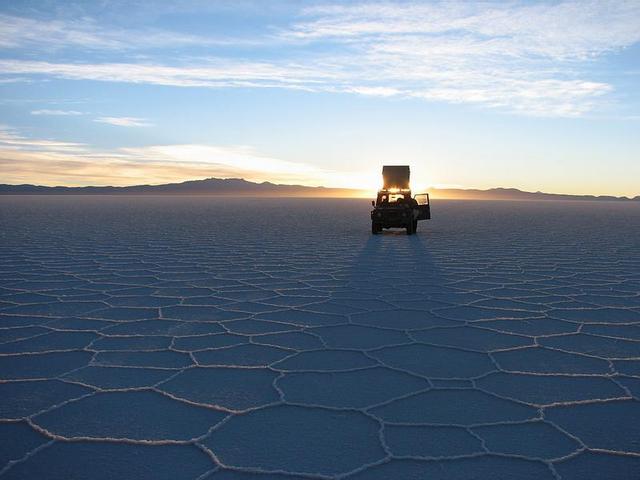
<box><xmin>0</xmin><ymin>197</ymin><xmax>640</xmax><ymax>480</ymax></box>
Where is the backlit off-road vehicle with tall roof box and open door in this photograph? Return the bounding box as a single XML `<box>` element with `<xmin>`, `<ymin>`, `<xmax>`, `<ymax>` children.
<box><xmin>371</xmin><ymin>165</ymin><xmax>431</xmax><ymax>235</ymax></box>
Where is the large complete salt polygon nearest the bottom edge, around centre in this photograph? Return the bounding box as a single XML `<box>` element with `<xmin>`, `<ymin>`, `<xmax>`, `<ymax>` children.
<box><xmin>204</xmin><ymin>406</ymin><xmax>386</xmax><ymax>475</ymax></box>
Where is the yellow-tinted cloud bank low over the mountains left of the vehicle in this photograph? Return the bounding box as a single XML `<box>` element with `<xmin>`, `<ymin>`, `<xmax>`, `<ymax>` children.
<box><xmin>0</xmin><ymin>126</ymin><xmax>353</xmax><ymax>186</ymax></box>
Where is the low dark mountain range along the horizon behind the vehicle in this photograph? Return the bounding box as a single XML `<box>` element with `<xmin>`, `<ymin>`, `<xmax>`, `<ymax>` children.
<box><xmin>0</xmin><ymin>178</ymin><xmax>640</xmax><ymax>202</ymax></box>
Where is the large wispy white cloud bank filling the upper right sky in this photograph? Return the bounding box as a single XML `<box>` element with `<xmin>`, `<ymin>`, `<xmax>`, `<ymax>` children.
<box><xmin>281</xmin><ymin>1</ymin><xmax>640</xmax><ymax>116</ymax></box>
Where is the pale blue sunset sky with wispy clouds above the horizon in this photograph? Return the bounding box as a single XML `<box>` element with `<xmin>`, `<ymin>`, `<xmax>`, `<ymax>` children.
<box><xmin>0</xmin><ymin>0</ymin><xmax>640</xmax><ymax>196</ymax></box>
